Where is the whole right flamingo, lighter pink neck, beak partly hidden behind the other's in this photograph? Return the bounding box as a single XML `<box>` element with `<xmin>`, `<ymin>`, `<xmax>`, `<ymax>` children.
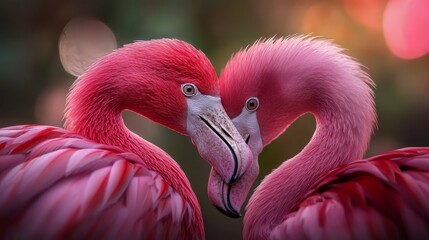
<box><xmin>209</xmin><ymin>36</ymin><xmax>429</xmax><ymax>239</ymax></box>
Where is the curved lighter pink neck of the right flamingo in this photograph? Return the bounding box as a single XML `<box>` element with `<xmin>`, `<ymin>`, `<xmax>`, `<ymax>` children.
<box><xmin>243</xmin><ymin>42</ymin><xmax>376</xmax><ymax>239</ymax></box>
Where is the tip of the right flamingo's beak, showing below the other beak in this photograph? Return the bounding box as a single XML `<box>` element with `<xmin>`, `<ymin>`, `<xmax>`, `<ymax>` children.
<box><xmin>208</xmin><ymin>158</ymin><xmax>259</xmax><ymax>218</ymax></box>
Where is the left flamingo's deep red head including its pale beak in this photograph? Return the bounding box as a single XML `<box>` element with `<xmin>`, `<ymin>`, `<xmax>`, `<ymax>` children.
<box><xmin>123</xmin><ymin>39</ymin><xmax>253</xmax><ymax>183</ymax></box>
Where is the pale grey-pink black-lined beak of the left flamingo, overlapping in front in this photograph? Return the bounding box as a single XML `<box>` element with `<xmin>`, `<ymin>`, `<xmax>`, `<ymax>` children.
<box><xmin>187</xmin><ymin>93</ymin><xmax>253</xmax><ymax>184</ymax></box>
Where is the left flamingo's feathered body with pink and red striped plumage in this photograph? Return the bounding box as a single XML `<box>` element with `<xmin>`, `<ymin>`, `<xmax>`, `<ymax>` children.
<box><xmin>0</xmin><ymin>125</ymin><xmax>197</xmax><ymax>239</ymax></box>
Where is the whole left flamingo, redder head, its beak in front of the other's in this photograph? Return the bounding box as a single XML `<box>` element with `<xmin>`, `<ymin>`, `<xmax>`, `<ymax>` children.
<box><xmin>0</xmin><ymin>39</ymin><xmax>253</xmax><ymax>239</ymax></box>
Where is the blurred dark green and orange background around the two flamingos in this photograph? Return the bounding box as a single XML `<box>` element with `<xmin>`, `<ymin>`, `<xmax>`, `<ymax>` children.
<box><xmin>0</xmin><ymin>0</ymin><xmax>429</xmax><ymax>239</ymax></box>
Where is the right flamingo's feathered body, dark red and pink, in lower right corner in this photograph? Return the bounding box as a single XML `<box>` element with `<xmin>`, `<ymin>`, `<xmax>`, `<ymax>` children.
<box><xmin>271</xmin><ymin>147</ymin><xmax>429</xmax><ymax>239</ymax></box>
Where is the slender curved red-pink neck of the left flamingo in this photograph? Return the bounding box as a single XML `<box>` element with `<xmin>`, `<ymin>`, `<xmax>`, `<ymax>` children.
<box><xmin>65</xmin><ymin>66</ymin><xmax>203</xmax><ymax>232</ymax></box>
